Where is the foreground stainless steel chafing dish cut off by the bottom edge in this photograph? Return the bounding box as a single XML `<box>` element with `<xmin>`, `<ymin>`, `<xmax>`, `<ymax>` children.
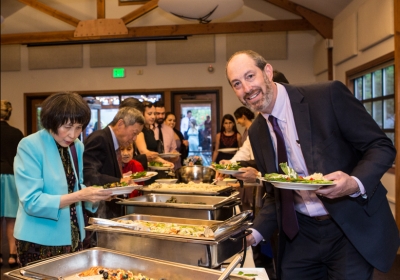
<box><xmin>4</xmin><ymin>248</ymin><xmax>253</xmax><ymax>280</ymax></box>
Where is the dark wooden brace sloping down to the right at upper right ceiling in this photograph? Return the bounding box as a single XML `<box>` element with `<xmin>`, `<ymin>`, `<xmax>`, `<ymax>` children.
<box><xmin>264</xmin><ymin>0</ymin><xmax>333</xmax><ymax>39</ymax></box>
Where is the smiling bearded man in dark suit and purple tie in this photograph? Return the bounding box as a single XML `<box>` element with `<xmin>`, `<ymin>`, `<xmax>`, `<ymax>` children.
<box><xmin>226</xmin><ymin>51</ymin><xmax>399</xmax><ymax>279</ymax></box>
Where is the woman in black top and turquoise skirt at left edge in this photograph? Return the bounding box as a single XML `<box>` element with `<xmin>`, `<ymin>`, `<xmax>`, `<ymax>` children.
<box><xmin>0</xmin><ymin>100</ymin><xmax>24</xmax><ymax>266</ymax></box>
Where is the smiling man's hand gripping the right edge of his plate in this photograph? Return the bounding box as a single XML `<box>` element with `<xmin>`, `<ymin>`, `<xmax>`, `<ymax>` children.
<box><xmin>315</xmin><ymin>171</ymin><xmax>360</xmax><ymax>199</ymax></box>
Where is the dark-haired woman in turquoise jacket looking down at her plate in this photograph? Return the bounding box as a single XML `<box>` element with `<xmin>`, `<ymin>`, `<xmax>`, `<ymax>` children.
<box><xmin>14</xmin><ymin>92</ymin><xmax>112</xmax><ymax>266</ymax></box>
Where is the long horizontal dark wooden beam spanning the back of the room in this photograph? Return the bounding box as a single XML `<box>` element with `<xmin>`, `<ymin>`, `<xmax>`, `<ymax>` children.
<box><xmin>1</xmin><ymin>19</ymin><xmax>314</xmax><ymax>45</ymax></box>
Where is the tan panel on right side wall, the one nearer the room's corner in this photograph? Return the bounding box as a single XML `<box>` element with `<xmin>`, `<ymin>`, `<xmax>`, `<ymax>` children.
<box><xmin>333</xmin><ymin>14</ymin><xmax>358</xmax><ymax>65</ymax></box>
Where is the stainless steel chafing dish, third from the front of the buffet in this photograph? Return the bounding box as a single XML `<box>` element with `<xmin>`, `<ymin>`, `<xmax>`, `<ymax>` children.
<box><xmin>117</xmin><ymin>193</ymin><xmax>240</xmax><ymax>220</ymax></box>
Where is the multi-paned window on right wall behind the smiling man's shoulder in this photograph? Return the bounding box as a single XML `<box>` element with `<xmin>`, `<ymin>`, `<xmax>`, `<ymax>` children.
<box><xmin>350</xmin><ymin>62</ymin><xmax>396</xmax><ymax>144</ymax></box>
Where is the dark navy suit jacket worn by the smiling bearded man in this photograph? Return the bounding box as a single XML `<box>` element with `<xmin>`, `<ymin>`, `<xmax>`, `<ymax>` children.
<box><xmin>249</xmin><ymin>81</ymin><xmax>399</xmax><ymax>272</ymax></box>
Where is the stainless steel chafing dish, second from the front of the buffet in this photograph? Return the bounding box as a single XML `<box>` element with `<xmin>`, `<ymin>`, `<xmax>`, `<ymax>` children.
<box><xmin>86</xmin><ymin>214</ymin><xmax>251</xmax><ymax>268</ymax></box>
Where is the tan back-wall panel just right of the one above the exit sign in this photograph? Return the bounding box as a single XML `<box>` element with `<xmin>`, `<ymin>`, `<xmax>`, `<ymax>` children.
<box><xmin>156</xmin><ymin>35</ymin><xmax>215</xmax><ymax>64</ymax></box>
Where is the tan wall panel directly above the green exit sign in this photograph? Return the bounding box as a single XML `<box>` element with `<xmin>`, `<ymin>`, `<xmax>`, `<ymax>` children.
<box><xmin>90</xmin><ymin>42</ymin><xmax>147</xmax><ymax>67</ymax></box>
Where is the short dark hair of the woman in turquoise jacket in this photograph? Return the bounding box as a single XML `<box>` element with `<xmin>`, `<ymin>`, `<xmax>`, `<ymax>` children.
<box><xmin>40</xmin><ymin>92</ymin><xmax>90</xmax><ymax>134</ymax></box>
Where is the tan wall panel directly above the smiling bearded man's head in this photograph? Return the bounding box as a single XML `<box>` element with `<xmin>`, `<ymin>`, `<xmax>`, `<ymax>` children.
<box><xmin>226</xmin><ymin>32</ymin><xmax>288</xmax><ymax>60</ymax></box>
